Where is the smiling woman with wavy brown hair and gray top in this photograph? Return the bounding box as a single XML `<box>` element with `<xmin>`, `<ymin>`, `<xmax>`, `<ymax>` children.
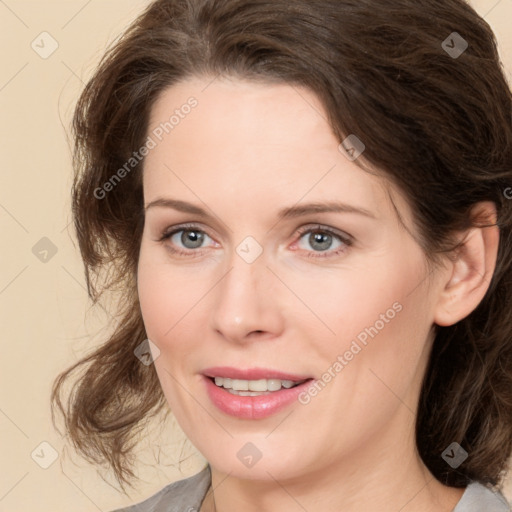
<box><xmin>53</xmin><ymin>0</ymin><xmax>512</xmax><ymax>512</ymax></box>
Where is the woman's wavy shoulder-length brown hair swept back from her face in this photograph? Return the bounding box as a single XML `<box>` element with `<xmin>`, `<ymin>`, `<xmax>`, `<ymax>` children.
<box><xmin>52</xmin><ymin>0</ymin><xmax>512</xmax><ymax>494</ymax></box>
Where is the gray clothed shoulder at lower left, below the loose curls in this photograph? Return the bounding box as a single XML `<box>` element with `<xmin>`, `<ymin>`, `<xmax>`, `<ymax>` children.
<box><xmin>112</xmin><ymin>465</ymin><xmax>211</xmax><ymax>512</ymax></box>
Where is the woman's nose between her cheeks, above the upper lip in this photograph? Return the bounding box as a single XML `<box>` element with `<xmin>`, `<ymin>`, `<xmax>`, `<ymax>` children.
<box><xmin>212</xmin><ymin>254</ymin><xmax>284</xmax><ymax>343</ymax></box>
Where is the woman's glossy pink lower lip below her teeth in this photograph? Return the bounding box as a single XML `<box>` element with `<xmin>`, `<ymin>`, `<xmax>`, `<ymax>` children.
<box><xmin>203</xmin><ymin>376</ymin><xmax>313</xmax><ymax>420</ymax></box>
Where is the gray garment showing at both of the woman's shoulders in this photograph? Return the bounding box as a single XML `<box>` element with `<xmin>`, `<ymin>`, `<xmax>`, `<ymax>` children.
<box><xmin>113</xmin><ymin>465</ymin><xmax>512</xmax><ymax>512</ymax></box>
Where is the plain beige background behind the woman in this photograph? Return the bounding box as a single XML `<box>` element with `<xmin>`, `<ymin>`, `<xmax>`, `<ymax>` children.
<box><xmin>0</xmin><ymin>0</ymin><xmax>512</xmax><ymax>512</ymax></box>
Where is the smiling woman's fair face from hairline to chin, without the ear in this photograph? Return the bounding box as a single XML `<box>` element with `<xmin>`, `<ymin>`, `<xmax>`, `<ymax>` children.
<box><xmin>138</xmin><ymin>79</ymin><xmax>448</xmax><ymax>480</ymax></box>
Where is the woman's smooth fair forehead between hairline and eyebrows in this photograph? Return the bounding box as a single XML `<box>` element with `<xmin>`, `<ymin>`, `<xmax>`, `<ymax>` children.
<box><xmin>144</xmin><ymin>78</ymin><xmax>405</xmax><ymax>226</ymax></box>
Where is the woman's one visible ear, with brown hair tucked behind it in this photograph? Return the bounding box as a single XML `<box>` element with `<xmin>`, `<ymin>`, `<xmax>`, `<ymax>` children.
<box><xmin>434</xmin><ymin>201</ymin><xmax>500</xmax><ymax>326</ymax></box>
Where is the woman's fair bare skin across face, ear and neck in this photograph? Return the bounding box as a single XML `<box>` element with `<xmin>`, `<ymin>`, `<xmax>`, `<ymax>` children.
<box><xmin>138</xmin><ymin>77</ymin><xmax>498</xmax><ymax>512</ymax></box>
